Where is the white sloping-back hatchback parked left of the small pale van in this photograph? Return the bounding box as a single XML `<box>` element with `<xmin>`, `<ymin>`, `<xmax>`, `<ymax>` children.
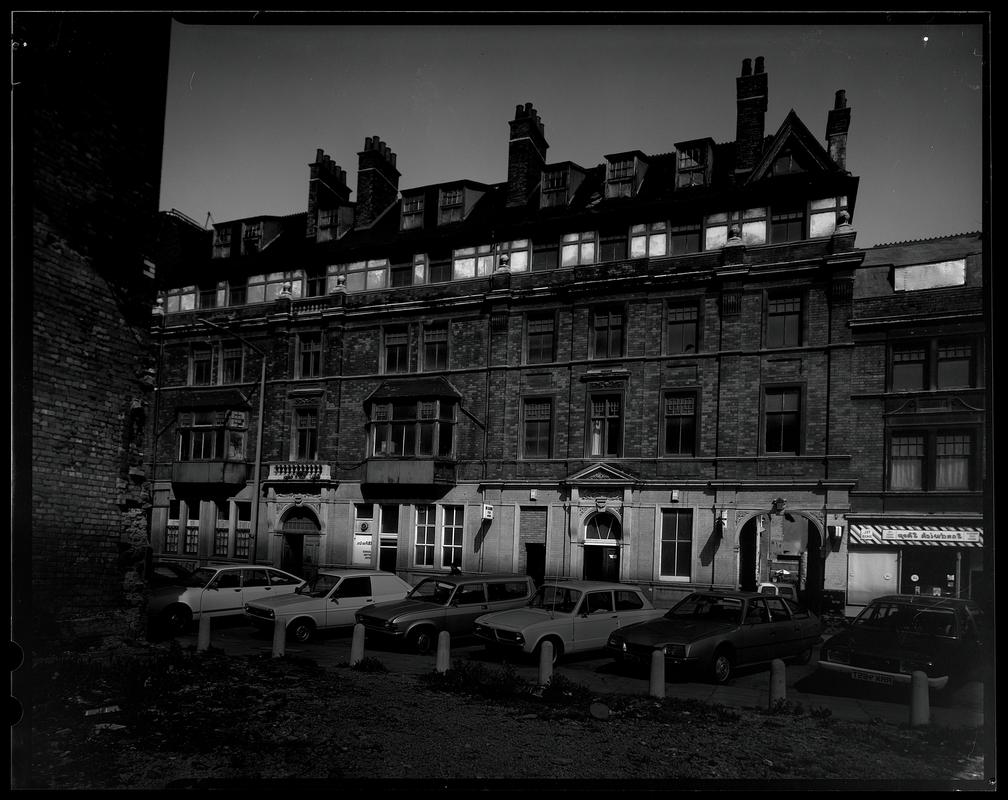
<box><xmin>147</xmin><ymin>564</ymin><xmax>304</xmax><ymax>633</ymax></box>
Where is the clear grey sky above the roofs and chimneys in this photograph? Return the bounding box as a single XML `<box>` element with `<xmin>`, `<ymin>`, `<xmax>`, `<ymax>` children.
<box><xmin>160</xmin><ymin>14</ymin><xmax>985</xmax><ymax>247</ymax></box>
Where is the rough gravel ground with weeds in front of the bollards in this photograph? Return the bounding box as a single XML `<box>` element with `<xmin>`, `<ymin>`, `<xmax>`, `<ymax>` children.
<box><xmin>19</xmin><ymin>647</ymin><xmax>984</xmax><ymax>790</ymax></box>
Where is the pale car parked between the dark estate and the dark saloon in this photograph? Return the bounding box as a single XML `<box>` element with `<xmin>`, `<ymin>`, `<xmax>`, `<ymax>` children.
<box><xmin>475</xmin><ymin>580</ymin><xmax>664</xmax><ymax>664</ymax></box>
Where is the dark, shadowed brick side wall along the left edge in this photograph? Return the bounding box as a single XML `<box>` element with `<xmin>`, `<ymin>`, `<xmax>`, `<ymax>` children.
<box><xmin>12</xmin><ymin>13</ymin><xmax>170</xmax><ymax>648</ymax></box>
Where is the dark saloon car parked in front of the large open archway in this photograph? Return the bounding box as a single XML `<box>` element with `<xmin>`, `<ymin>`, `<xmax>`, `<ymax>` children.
<box><xmin>607</xmin><ymin>589</ymin><xmax>823</xmax><ymax>683</ymax></box>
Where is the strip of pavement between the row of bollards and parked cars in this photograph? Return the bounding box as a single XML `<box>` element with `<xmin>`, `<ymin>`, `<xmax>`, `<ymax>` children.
<box><xmin>176</xmin><ymin>619</ymin><xmax>985</xmax><ymax>728</ymax></box>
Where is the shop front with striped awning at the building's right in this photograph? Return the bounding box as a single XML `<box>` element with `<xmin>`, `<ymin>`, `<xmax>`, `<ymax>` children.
<box><xmin>848</xmin><ymin>523</ymin><xmax>984</xmax><ymax>614</ymax></box>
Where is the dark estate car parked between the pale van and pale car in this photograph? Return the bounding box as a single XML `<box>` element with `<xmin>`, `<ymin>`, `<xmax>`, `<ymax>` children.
<box><xmin>357</xmin><ymin>575</ymin><xmax>535</xmax><ymax>653</ymax></box>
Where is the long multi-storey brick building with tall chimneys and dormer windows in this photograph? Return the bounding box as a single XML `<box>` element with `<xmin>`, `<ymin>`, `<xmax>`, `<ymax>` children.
<box><xmin>151</xmin><ymin>58</ymin><xmax>899</xmax><ymax>608</ymax></box>
